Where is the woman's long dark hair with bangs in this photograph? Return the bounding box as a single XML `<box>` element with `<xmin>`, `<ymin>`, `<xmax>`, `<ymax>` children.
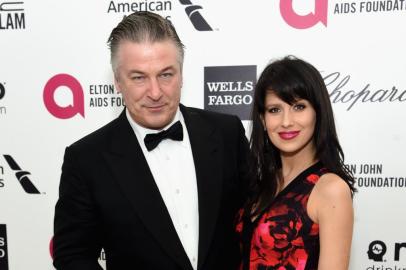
<box><xmin>245</xmin><ymin>56</ymin><xmax>355</xmax><ymax>217</ymax></box>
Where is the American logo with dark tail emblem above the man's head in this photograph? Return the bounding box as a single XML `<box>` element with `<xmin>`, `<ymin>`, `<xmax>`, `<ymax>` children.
<box><xmin>107</xmin><ymin>0</ymin><xmax>213</xmax><ymax>31</ymax></box>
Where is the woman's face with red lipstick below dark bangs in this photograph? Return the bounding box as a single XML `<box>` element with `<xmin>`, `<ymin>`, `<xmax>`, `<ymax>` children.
<box><xmin>263</xmin><ymin>91</ymin><xmax>316</xmax><ymax>155</ymax></box>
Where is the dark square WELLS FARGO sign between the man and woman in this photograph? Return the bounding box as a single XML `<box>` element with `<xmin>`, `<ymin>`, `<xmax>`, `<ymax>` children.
<box><xmin>204</xmin><ymin>66</ymin><xmax>257</xmax><ymax>120</ymax></box>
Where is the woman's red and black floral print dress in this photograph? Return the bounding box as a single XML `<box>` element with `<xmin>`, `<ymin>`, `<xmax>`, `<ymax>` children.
<box><xmin>236</xmin><ymin>162</ymin><xmax>327</xmax><ymax>270</ymax></box>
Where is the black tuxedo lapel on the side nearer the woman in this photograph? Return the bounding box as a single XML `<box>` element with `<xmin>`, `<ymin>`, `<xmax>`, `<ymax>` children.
<box><xmin>180</xmin><ymin>105</ymin><xmax>223</xmax><ymax>269</ymax></box>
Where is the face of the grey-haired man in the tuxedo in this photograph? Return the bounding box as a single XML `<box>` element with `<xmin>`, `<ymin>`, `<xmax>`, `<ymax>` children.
<box><xmin>115</xmin><ymin>40</ymin><xmax>182</xmax><ymax>129</ymax></box>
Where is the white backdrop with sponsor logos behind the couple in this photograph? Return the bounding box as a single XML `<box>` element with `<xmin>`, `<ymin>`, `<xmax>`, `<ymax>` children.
<box><xmin>0</xmin><ymin>0</ymin><xmax>406</xmax><ymax>270</ymax></box>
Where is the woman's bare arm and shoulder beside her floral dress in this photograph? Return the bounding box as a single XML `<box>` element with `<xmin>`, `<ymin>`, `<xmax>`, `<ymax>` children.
<box><xmin>307</xmin><ymin>173</ymin><xmax>354</xmax><ymax>270</ymax></box>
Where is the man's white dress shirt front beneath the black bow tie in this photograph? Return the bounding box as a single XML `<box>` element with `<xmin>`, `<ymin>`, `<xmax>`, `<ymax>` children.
<box><xmin>126</xmin><ymin>108</ymin><xmax>199</xmax><ymax>270</ymax></box>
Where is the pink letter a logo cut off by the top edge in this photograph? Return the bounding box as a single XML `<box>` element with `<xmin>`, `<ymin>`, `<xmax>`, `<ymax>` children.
<box><xmin>280</xmin><ymin>0</ymin><xmax>328</xmax><ymax>29</ymax></box>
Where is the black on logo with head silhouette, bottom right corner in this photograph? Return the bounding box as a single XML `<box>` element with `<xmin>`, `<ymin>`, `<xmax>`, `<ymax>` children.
<box><xmin>366</xmin><ymin>240</ymin><xmax>406</xmax><ymax>270</ymax></box>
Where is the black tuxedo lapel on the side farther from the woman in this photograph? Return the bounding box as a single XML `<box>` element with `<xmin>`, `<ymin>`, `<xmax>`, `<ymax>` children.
<box><xmin>100</xmin><ymin>112</ymin><xmax>192</xmax><ymax>269</ymax></box>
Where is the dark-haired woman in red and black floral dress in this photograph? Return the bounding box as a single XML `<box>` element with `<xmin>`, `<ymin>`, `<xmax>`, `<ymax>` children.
<box><xmin>236</xmin><ymin>56</ymin><xmax>355</xmax><ymax>270</ymax></box>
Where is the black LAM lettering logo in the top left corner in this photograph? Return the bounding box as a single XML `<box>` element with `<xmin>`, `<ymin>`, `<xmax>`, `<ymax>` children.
<box><xmin>0</xmin><ymin>1</ymin><xmax>25</xmax><ymax>30</ymax></box>
